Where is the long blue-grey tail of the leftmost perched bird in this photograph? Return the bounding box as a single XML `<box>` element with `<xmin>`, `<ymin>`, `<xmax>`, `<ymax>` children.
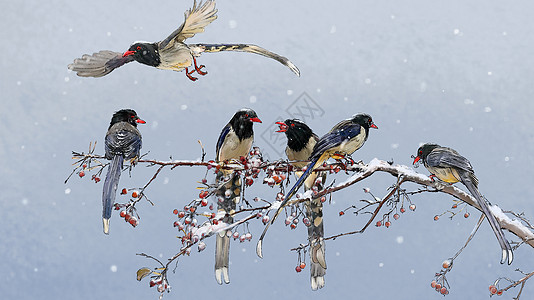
<box><xmin>102</xmin><ymin>155</ymin><xmax>124</xmax><ymax>234</ymax></box>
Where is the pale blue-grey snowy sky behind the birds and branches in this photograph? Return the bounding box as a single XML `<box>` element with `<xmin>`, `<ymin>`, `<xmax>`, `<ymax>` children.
<box><xmin>0</xmin><ymin>0</ymin><xmax>534</xmax><ymax>299</ymax></box>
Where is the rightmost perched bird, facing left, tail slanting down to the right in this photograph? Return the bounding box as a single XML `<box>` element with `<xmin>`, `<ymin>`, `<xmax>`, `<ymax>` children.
<box><xmin>413</xmin><ymin>144</ymin><xmax>514</xmax><ymax>264</ymax></box>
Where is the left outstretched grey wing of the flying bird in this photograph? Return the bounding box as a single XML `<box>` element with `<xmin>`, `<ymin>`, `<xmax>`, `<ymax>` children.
<box><xmin>68</xmin><ymin>50</ymin><xmax>134</xmax><ymax>77</ymax></box>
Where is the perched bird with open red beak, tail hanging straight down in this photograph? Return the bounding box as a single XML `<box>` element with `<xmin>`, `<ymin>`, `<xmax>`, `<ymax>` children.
<box><xmin>276</xmin><ymin>119</ymin><xmax>326</xmax><ymax>290</ymax></box>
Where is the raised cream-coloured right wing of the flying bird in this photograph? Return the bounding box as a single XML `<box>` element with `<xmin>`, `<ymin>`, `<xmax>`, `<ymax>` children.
<box><xmin>159</xmin><ymin>0</ymin><xmax>217</xmax><ymax>49</ymax></box>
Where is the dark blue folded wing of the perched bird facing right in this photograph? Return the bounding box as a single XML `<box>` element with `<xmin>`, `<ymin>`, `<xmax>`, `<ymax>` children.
<box><xmin>310</xmin><ymin>120</ymin><xmax>361</xmax><ymax>159</ymax></box>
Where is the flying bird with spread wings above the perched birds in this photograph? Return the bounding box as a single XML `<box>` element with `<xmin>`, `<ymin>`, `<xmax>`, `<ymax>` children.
<box><xmin>68</xmin><ymin>0</ymin><xmax>300</xmax><ymax>81</ymax></box>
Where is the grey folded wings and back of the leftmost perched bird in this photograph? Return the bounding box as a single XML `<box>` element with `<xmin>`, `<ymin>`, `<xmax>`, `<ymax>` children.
<box><xmin>105</xmin><ymin>124</ymin><xmax>142</xmax><ymax>159</ymax></box>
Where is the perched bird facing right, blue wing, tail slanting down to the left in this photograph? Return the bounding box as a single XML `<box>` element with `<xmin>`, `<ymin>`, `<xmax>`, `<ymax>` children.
<box><xmin>256</xmin><ymin>114</ymin><xmax>378</xmax><ymax>258</ymax></box>
